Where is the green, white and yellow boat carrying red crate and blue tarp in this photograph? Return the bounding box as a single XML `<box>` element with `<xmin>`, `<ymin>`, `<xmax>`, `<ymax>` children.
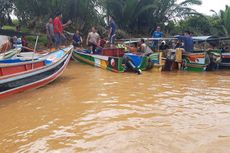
<box><xmin>72</xmin><ymin>49</ymin><xmax>151</xmax><ymax>72</ymax></box>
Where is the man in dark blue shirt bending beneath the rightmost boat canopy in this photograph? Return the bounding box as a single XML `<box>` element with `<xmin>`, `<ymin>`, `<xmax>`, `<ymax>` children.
<box><xmin>176</xmin><ymin>31</ymin><xmax>194</xmax><ymax>52</ymax></box>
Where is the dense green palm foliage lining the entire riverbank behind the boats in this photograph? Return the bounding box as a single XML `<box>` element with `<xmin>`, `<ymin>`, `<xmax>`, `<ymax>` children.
<box><xmin>0</xmin><ymin>0</ymin><xmax>230</xmax><ymax>36</ymax></box>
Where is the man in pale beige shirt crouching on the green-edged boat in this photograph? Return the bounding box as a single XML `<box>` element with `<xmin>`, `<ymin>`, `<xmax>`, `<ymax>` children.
<box><xmin>86</xmin><ymin>27</ymin><xmax>100</xmax><ymax>54</ymax></box>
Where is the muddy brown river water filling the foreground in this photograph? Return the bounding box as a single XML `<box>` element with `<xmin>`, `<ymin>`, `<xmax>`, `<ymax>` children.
<box><xmin>0</xmin><ymin>62</ymin><xmax>230</xmax><ymax>153</ymax></box>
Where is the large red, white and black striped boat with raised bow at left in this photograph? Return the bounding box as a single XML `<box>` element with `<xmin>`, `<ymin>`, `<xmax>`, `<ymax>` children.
<box><xmin>0</xmin><ymin>46</ymin><xmax>73</xmax><ymax>99</ymax></box>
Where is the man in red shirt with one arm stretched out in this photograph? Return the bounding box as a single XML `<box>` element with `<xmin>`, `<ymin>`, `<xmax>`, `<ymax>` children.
<box><xmin>54</xmin><ymin>12</ymin><xmax>71</xmax><ymax>48</ymax></box>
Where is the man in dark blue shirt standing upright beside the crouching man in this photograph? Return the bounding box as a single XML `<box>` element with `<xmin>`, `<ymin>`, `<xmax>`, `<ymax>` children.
<box><xmin>109</xmin><ymin>16</ymin><xmax>117</xmax><ymax>47</ymax></box>
